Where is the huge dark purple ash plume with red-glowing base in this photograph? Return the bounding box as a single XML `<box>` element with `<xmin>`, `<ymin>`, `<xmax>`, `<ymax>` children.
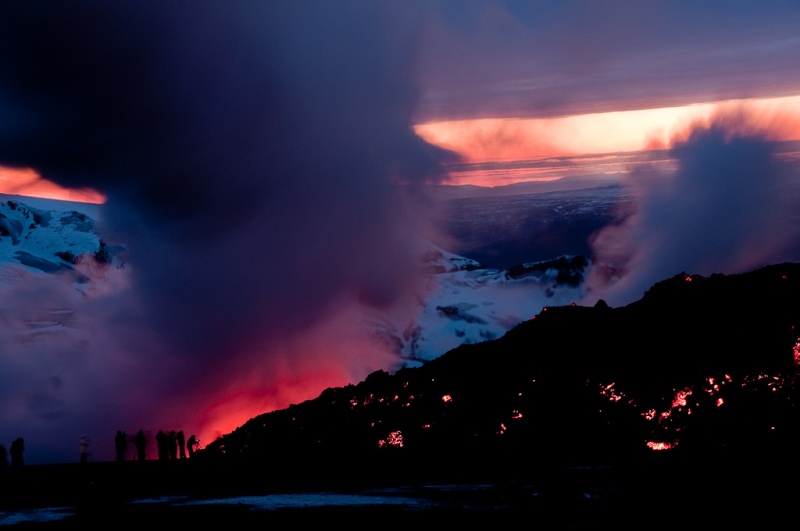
<box><xmin>0</xmin><ymin>0</ymin><xmax>450</xmax><ymax>459</ymax></box>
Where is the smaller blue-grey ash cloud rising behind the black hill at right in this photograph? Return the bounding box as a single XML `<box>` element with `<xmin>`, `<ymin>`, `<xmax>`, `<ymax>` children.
<box><xmin>588</xmin><ymin>107</ymin><xmax>800</xmax><ymax>306</ymax></box>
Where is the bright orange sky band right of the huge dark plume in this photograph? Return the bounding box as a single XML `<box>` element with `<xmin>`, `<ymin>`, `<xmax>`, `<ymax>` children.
<box><xmin>414</xmin><ymin>96</ymin><xmax>800</xmax><ymax>186</ymax></box>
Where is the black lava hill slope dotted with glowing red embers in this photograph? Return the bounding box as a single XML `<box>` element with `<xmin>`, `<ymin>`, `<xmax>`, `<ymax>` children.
<box><xmin>199</xmin><ymin>263</ymin><xmax>800</xmax><ymax>502</ymax></box>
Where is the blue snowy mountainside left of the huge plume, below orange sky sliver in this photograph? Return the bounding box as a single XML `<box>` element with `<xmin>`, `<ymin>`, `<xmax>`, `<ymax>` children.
<box><xmin>0</xmin><ymin>194</ymin><xmax>122</xmax><ymax>358</ymax></box>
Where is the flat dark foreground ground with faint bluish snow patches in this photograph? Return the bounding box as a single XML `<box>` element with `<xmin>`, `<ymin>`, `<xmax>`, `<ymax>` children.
<box><xmin>0</xmin><ymin>452</ymin><xmax>800</xmax><ymax>530</ymax></box>
